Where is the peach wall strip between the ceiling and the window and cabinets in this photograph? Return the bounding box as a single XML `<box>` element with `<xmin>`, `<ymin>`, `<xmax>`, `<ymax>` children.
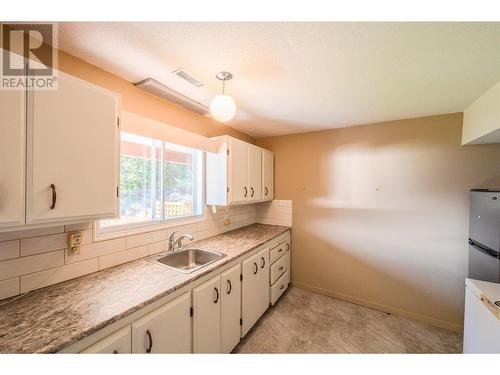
<box><xmin>58</xmin><ymin>51</ymin><xmax>254</xmax><ymax>143</ymax></box>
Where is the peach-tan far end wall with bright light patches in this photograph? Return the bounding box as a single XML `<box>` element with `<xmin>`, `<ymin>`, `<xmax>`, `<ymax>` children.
<box><xmin>256</xmin><ymin>113</ymin><xmax>500</xmax><ymax>330</ymax></box>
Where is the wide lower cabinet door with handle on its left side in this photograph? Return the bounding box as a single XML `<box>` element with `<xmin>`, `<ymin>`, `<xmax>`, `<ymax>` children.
<box><xmin>132</xmin><ymin>292</ymin><xmax>191</xmax><ymax>353</ymax></box>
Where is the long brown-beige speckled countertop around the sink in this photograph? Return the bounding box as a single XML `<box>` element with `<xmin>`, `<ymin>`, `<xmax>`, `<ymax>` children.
<box><xmin>0</xmin><ymin>224</ymin><xmax>290</xmax><ymax>353</ymax></box>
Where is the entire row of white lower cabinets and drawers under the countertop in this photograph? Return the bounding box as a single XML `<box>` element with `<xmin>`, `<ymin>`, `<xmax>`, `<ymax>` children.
<box><xmin>75</xmin><ymin>232</ymin><xmax>290</xmax><ymax>353</ymax></box>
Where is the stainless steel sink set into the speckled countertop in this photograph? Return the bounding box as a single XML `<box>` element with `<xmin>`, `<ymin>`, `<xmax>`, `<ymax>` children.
<box><xmin>150</xmin><ymin>248</ymin><xmax>226</xmax><ymax>273</ymax></box>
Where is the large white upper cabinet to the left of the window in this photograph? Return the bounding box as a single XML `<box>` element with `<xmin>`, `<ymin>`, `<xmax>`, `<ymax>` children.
<box><xmin>0</xmin><ymin>72</ymin><xmax>120</xmax><ymax>231</ymax></box>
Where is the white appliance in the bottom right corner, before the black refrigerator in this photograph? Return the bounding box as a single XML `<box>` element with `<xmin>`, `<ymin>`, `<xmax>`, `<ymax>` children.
<box><xmin>463</xmin><ymin>279</ymin><xmax>500</xmax><ymax>353</ymax></box>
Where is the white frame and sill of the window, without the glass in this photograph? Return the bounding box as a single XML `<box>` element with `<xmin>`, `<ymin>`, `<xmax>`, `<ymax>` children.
<box><xmin>92</xmin><ymin>132</ymin><xmax>207</xmax><ymax>242</ymax></box>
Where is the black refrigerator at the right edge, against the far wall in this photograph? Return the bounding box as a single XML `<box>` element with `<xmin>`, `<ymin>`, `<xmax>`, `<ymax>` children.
<box><xmin>468</xmin><ymin>190</ymin><xmax>500</xmax><ymax>283</ymax></box>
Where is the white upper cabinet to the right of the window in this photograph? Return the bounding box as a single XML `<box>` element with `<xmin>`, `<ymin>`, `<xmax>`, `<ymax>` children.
<box><xmin>206</xmin><ymin>136</ymin><xmax>274</xmax><ymax>206</ymax></box>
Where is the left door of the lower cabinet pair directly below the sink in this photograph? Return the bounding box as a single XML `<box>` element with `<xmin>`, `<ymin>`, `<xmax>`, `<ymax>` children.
<box><xmin>193</xmin><ymin>276</ymin><xmax>222</xmax><ymax>353</ymax></box>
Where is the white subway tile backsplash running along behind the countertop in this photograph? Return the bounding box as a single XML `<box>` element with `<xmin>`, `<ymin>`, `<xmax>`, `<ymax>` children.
<box><xmin>0</xmin><ymin>200</ymin><xmax>292</xmax><ymax>299</ymax></box>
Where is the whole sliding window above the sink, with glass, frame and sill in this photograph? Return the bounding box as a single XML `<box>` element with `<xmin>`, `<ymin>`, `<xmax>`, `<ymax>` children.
<box><xmin>98</xmin><ymin>132</ymin><xmax>203</xmax><ymax>236</ymax></box>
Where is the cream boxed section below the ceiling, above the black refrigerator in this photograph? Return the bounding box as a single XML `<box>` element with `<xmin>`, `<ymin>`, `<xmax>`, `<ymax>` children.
<box><xmin>462</xmin><ymin>82</ymin><xmax>500</xmax><ymax>145</ymax></box>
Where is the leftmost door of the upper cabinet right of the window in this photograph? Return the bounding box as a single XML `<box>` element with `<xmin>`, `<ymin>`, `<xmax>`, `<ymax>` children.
<box><xmin>228</xmin><ymin>138</ymin><xmax>250</xmax><ymax>203</ymax></box>
